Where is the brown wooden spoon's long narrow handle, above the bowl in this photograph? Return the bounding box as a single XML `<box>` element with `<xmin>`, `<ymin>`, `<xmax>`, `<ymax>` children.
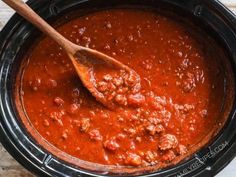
<box><xmin>2</xmin><ymin>0</ymin><xmax>78</xmax><ymax>55</ymax></box>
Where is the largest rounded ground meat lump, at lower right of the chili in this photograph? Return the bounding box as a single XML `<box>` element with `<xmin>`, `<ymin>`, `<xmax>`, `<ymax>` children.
<box><xmin>158</xmin><ymin>134</ymin><xmax>178</xmax><ymax>150</ymax></box>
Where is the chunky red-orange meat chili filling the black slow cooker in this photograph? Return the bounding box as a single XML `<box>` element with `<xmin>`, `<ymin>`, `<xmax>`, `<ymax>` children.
<box><xmin>17</xmin><ymin>9</ymin><xmax>227</xmax><ymax>169</ymax></box>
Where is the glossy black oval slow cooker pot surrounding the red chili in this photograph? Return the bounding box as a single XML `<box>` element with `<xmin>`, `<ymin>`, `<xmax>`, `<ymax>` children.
<box><xmin>0</xmin><ymin>0</ymin><xmax>236</xmax><ymax>177</ymax></box>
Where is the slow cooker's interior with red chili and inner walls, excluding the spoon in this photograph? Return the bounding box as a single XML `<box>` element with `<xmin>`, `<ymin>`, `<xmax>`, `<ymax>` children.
<box><xmin>2</xmin><ymin>1</ymin><xmax>234</xmax><ymax>175</ymax></box>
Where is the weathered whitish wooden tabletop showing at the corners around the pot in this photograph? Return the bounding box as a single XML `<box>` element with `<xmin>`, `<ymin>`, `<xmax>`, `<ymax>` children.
<box><xmin>0</xmin><ymin>0</ymin><xmax>236</xmax><ymax>177</ymax></box>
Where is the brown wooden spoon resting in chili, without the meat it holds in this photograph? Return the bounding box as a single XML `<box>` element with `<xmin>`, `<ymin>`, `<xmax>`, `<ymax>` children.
<box><xmin>3</xmin><ymin>0</ymin><xmax>139</xmax><ymax>107</ymax></box>
